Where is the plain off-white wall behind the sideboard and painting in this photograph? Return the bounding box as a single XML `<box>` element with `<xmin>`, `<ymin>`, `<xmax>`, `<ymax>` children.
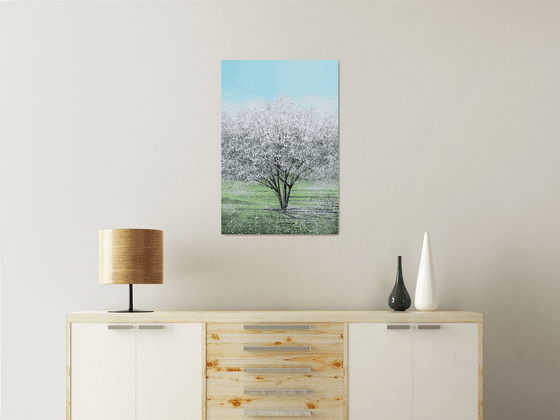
<box><xmin>0</xmin><ymin>2</ymin><xmax>560</xmax><ymax>420</ymax></box>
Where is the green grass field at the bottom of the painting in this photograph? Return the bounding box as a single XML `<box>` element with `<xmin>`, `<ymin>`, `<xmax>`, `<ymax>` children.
<box><xmin>222</xmin><ymin>181</ymin><xmax>338</xmax><ymax>235</ymax></box>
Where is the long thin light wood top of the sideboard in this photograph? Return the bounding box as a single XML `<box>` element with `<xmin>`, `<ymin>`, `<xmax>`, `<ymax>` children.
<box><xmin>66</xmin><ymin>310</ymin><xmax>482</xmax><ymax>323</ymax></box>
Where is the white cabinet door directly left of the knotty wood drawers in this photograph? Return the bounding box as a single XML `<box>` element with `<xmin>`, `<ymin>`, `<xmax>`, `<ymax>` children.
<box><xmin>136</xmin><ymin>323</ymin><xmax>203</xmax><ymax>420</ymax></box>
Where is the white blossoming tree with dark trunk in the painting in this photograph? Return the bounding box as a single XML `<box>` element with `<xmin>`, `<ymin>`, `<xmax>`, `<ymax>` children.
<box><xmin>222</xmin><ymin>96</ymin><xmax>338</xmax><ymax>210</ymax></box>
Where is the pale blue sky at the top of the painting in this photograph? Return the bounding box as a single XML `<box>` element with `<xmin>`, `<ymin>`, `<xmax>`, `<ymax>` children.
<box><xmin>222</xmin><ymin>60</ymin><xmax>338</xmax><ymax>111</ymax></box>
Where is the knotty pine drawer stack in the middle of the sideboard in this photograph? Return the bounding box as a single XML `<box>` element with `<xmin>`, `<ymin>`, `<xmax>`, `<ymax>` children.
<box><xmin>206</xmin><ymin>323</ymin><xmax>345</xmax><ymax>420</ymax></box>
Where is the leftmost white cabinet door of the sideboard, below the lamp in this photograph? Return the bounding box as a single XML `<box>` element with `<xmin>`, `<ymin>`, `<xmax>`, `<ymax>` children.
<box><xmin>72</xmin><ymin>323</ymin><xmax>135</xmax><ymax>420</ymax></box>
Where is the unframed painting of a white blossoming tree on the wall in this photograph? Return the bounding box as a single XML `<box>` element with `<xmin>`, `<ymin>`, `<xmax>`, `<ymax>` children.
<box><xmin>221</xmin><ymin>60</ymin><xmax>339</xmax><ymax>235</ymax></box>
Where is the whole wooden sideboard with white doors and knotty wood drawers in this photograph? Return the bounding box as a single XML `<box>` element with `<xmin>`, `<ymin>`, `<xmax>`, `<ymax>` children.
<box><xmin>66</xmin><ymin>311</ymin><xmax>482</xmax><ymax>420</ymax></box>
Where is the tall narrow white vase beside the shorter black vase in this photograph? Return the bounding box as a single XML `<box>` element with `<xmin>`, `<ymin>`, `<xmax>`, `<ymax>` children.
<box><xmin>414</xmin><ymin>232</ymin><xmax>439</xmax><ymax>311</ymax></box>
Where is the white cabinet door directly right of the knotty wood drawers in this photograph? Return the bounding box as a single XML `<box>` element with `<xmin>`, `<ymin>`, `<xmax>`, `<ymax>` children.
<box><xmin>348</xmin><ymin>323</ymin><xmax>412</xmax><ymax>420</ymax></box>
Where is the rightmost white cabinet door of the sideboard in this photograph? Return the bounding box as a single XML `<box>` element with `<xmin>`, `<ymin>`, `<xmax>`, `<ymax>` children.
<box><xmin>413</xmin><ymin>324</ymin><xmax>478</xmax><ymax>420</ymax></box>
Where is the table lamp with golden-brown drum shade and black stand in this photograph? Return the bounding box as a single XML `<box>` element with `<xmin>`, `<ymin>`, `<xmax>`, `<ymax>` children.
<box><xmin>99</xmin><ymin>229</ymin><xmax>163</xmax><ymax>312</ymax></box>
